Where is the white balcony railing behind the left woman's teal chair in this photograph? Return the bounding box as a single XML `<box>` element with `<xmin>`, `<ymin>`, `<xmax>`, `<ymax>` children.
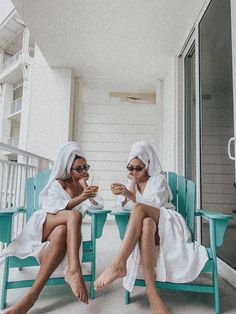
<box><xmin>0</xmin><ymin>142</ymin><xmax>52</xmax><ymax>240</ymax></box>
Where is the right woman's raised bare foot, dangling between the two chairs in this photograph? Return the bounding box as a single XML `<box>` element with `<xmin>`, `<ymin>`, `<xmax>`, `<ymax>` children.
<box><xmin>94</xmin><ymin>264</ymin><xmax>127</xmax><ymax>290</ymax></box>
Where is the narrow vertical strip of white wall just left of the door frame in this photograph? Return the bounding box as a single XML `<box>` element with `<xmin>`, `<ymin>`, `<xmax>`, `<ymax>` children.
<box><xmin>161</xmin><ymin>58</ymin><xmax>176</xmax><ymax>171</ymax></box>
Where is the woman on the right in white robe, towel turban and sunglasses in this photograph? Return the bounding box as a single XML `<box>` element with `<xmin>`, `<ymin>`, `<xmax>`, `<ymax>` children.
<box><xmin>95</xmin><ymin>142</ymin><xmax>208</xmax><ymax>314</ymax></box>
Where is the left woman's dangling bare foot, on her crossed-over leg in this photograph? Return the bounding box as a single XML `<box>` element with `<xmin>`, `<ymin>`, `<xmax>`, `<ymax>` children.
<box><xmin>65</xmin><ymin>270</ymin><xmax>88</xmax><ymax>304</ymax></box>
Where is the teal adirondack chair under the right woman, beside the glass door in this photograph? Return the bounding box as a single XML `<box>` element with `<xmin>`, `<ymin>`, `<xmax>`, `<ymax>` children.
<box><xmin>111</xmin><ymin>172</ymin><xmax>233</xmax><ymax>314</ymax></box>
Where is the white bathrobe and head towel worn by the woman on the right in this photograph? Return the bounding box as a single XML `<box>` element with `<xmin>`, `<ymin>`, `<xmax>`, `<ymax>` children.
<box><xmin>123</xmin><ymin>142</ymin><xmax>208</xmax><ymax>291</ymax></box>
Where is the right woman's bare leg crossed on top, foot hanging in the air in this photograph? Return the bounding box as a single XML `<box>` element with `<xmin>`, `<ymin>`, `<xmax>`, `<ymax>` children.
<box><xmin>95</xmin><ymin>203</ymin><xmax>160</xmax><ymax>290</ymax></box>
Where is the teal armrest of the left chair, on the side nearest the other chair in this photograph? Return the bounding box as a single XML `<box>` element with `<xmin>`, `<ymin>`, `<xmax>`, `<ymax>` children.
<box><xmin>87</xmin><ymin>208</ymin><xmax>111</xmax><ymax>240</ymax></box>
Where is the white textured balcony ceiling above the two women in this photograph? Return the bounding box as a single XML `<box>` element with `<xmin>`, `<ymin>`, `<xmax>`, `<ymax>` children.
<box><xmin>12</xmin><ymin>0</ymin><xmax>204</xmax><ymax>92</ymax></box>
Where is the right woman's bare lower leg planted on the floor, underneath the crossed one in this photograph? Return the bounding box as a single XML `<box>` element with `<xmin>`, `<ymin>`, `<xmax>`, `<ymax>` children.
<box><xmin>140</xmin><ymin>218</ymin><xmax>168</xmax><ymax>314</ymax></box>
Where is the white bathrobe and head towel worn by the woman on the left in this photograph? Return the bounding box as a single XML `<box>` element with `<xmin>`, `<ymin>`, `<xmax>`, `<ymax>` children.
<box><xmin>0</xmin><ymin>142</ymin><xmax>103</xmax><ymax>270</ymax></box>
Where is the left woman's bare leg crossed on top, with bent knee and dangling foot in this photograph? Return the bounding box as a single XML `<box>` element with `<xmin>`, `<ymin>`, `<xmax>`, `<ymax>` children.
<box><xmin>43</xmin><ymin>210</ymin><xmax>88</xmax><ymax>304</ymax></box>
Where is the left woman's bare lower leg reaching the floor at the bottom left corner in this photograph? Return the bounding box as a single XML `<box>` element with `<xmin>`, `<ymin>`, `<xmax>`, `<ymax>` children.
<box><xmin>4</xmin><ymin>225</ymin><xmax>66</xmax><ymax>314</ymax></box>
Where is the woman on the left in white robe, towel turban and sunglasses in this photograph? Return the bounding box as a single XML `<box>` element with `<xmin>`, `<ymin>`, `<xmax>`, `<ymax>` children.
<box><xmin>0</xmin><ymin>142</ymin><xmax>103</xmax><ymax>314</ymax></box>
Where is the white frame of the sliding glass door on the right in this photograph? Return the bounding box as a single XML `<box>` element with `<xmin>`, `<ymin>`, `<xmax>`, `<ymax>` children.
<box><xmin>175</xmin><ymin>0</ymin><xmax>236</xmax><ymax>287</ymax></box>
